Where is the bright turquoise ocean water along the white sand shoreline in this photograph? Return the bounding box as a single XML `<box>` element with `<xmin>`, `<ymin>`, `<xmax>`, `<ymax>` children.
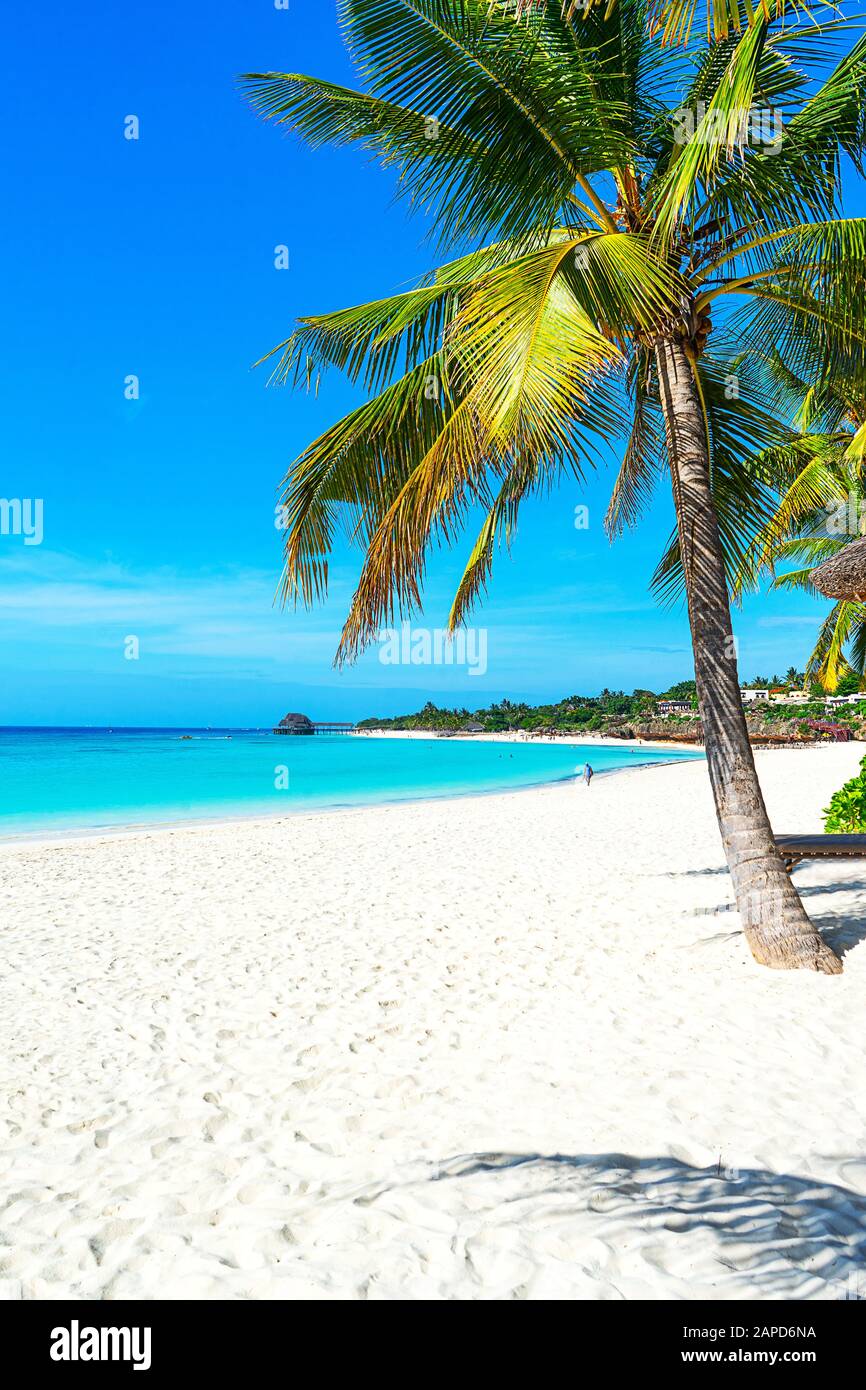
<box><xmin>0</xmin><ymin>728</ymin><xmax>695</xmax><ymax>837</ymax></box>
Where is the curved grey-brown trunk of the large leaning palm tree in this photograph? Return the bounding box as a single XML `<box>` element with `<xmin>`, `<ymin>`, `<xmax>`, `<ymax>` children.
<box><xmin>656</xmin><ymin>339</ymin><xmax>842</xmax><ymax>974</ymax></box>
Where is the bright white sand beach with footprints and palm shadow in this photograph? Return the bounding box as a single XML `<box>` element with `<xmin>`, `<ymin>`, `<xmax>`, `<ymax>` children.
<box><xmin>0</xmin><ymin>744</ymin><xmax>866</xmax><ymax>1300</ymax></box>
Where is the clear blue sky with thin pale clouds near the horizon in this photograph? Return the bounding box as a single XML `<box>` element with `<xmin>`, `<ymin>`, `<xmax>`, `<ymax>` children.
<box><xmin>0</xmin><ymin>0</ymin><xmax>856</xmax><ymax>726</ymax></box>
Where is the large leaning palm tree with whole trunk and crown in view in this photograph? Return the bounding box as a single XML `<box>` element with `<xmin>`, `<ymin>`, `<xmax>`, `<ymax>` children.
<box><xmin>245</xmin><ymin>0</ymin><xmax>866</xmax><ymax>973</ymax></box>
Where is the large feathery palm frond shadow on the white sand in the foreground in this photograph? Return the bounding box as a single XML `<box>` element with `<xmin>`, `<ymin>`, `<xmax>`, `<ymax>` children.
<box><xmin>354</xmin><ymin>1152</ymin><xmax>866</xmax><ymax>1300</ymax></box>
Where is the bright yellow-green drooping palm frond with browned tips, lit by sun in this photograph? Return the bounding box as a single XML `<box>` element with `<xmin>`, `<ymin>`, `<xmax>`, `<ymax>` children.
<box><xmin>338</xmin><ymin>243</ymin><xmax>631</xmax><ymax>660</ymax></box>
